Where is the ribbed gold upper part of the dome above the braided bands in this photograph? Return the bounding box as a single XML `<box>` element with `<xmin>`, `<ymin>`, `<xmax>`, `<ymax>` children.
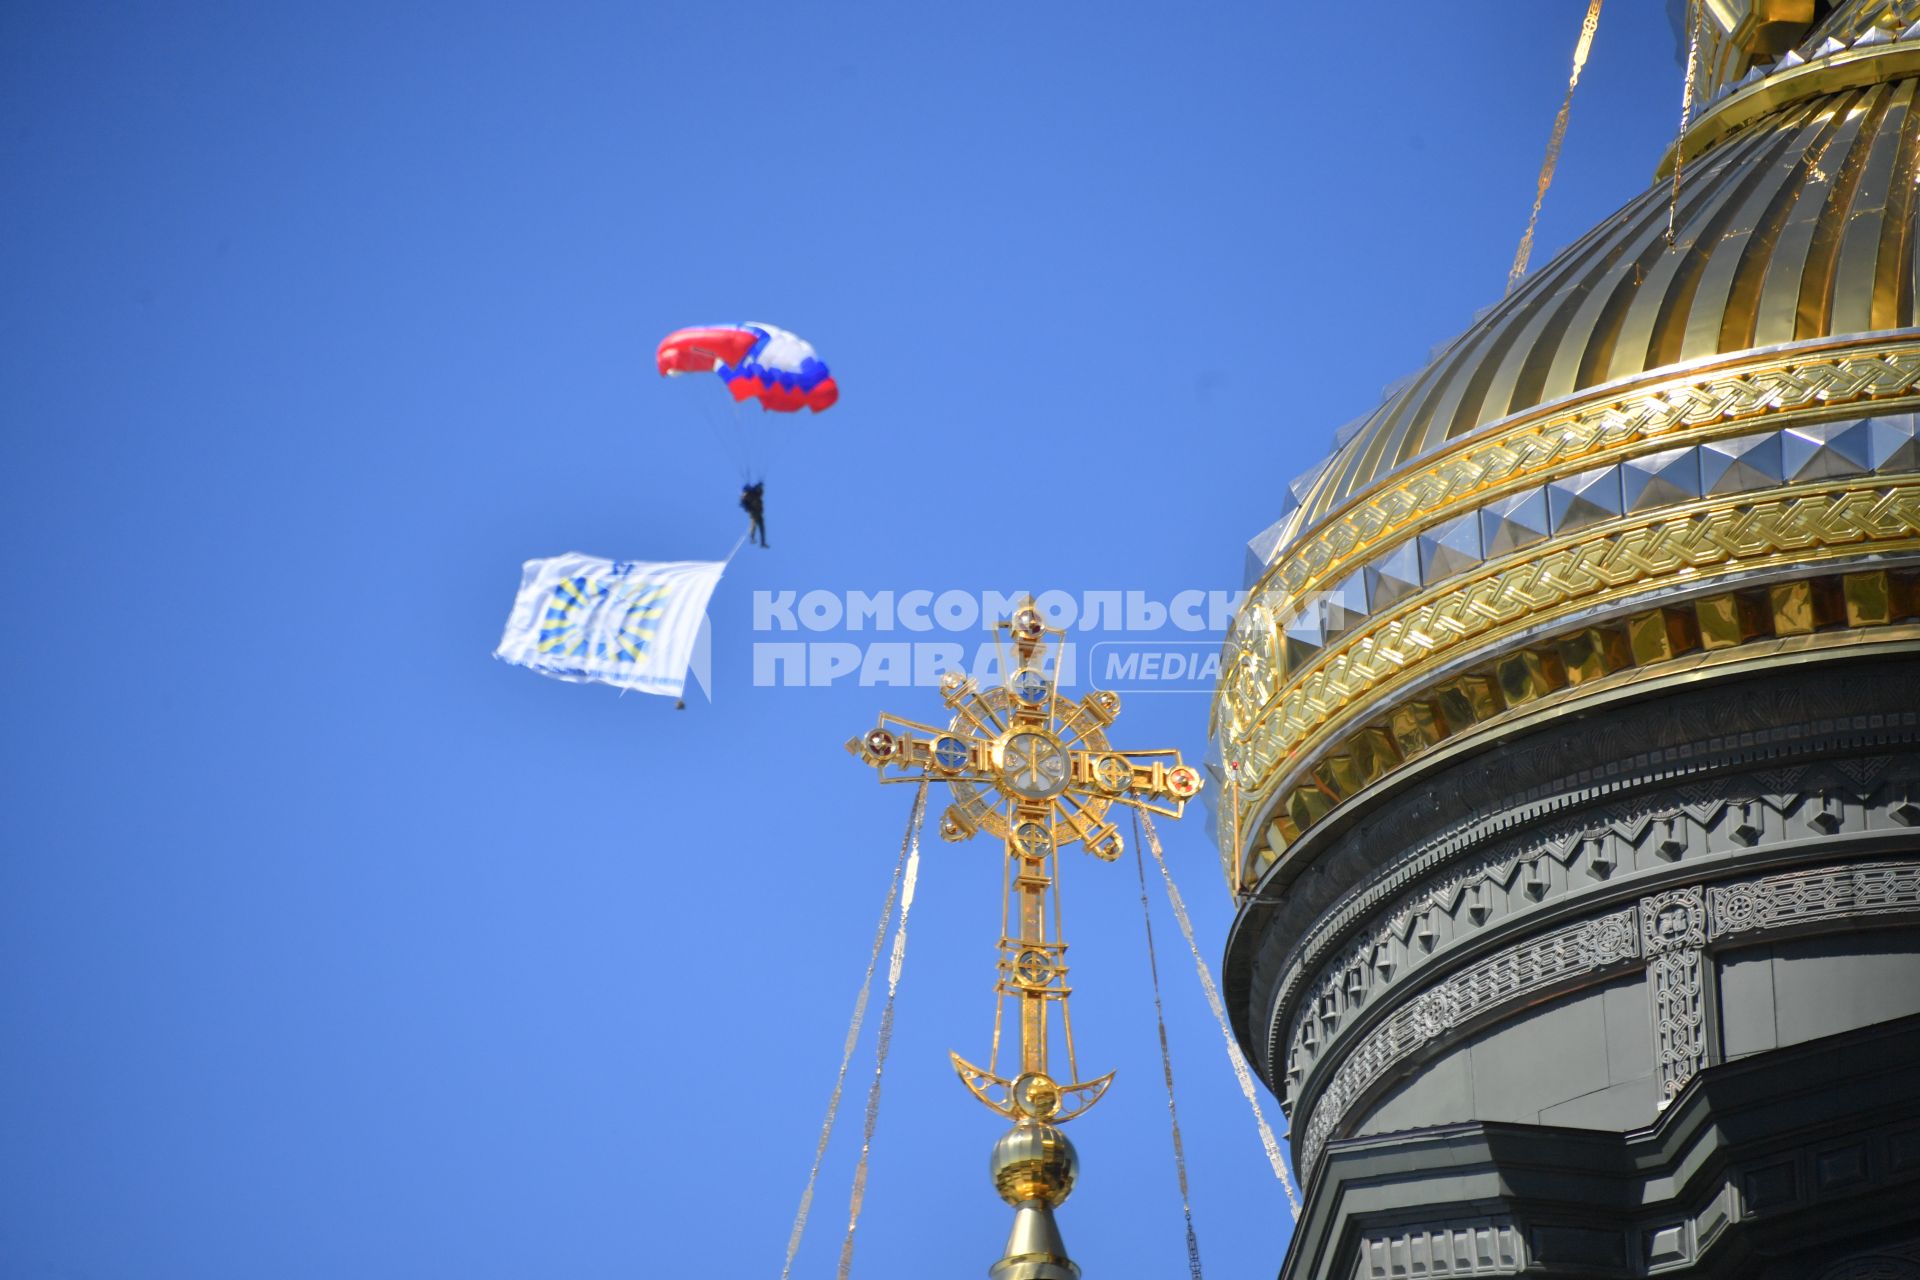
<box><xmin>1298</xmin><ymin>42</ymin><xmax>1920</xmax><ymax>528</ymax></box>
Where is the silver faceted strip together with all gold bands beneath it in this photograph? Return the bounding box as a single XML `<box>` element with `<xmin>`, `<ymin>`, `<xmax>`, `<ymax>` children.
<box><xmin>1215</xmin><ymin>383</ymin><xmax>1920</xmax><ymax>892</ymax></box>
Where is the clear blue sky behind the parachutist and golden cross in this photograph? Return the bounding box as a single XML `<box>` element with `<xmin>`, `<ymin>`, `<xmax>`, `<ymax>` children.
<box><xmin>0</xmin><ymin>0</ymin><xmax>1680</xmax><ymax>1280</ymax></box>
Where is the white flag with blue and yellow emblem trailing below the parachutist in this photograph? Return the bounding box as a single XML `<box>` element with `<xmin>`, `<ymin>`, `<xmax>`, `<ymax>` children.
<box><xmin>493</xmin><ymin>551</ymin><xmax>726</xmax><ymax>699</ymax></box>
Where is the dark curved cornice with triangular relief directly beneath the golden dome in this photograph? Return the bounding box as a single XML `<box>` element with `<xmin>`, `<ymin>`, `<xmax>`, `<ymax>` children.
<box><xmin>1246</xmin><ymin>687</ymin><xmax>1920</xmax><ymax>1080</ymax></box>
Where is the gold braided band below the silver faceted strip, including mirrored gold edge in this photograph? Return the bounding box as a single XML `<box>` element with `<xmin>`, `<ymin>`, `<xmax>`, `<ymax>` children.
<box><xmin>1221</xmin><ymin>476</ymin><xmax>1920</xmax><ymax>892</ymax></box>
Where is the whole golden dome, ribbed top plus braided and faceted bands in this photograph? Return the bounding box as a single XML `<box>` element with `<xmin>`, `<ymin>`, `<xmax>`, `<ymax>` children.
<box><xmin>1213</xmin><ymin>0</ymin><xmax>1920</xmax><ymax>892</ymax></box>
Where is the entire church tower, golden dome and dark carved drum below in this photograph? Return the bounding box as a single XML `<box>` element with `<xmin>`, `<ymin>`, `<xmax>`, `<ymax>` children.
<box><xmin>1212</xmin><ymin>0</ymin><xmax>1920</xmax><ymax>1280</ymax></box>
